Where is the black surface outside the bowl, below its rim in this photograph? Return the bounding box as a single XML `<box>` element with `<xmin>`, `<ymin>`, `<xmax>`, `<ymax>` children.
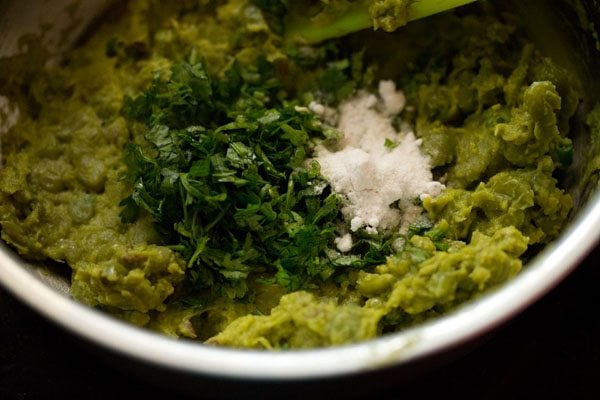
<box><xmin>0</xmin><ymin>246</ymin><xmax>600</xmax><ymax>400</ymax></box>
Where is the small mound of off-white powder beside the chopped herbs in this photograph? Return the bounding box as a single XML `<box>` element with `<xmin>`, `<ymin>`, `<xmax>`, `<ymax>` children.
<box><xmin>309</xmin><ymin>81</ymin><xmax>444</xmax><ymax>238</ymax></box>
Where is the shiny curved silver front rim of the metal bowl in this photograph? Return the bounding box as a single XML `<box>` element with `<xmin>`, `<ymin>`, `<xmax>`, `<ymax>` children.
<box><xmin>0</xmin><ymin>192</ymin><xmax>600</xmax><ymax>381</ymax></box>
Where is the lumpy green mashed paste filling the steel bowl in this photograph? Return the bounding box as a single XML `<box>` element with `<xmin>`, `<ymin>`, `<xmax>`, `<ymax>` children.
<box><xmin>0</xmin><ymin>0</ymin><xmax>580</xmax><ymax>349</ymax></box>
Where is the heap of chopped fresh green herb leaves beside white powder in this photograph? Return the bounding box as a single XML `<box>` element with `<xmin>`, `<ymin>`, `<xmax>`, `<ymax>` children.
<box><xmin>121</xmin><ymin>57</ymin><xmax>391</xmax><ymax>298</ymax></box>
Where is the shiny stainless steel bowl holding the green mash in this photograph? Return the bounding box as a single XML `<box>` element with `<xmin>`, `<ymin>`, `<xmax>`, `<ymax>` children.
<box><xmin>0</xmin><ymin>0</ymin><xmax>600</xmax><ymax>393</ymax></box>
